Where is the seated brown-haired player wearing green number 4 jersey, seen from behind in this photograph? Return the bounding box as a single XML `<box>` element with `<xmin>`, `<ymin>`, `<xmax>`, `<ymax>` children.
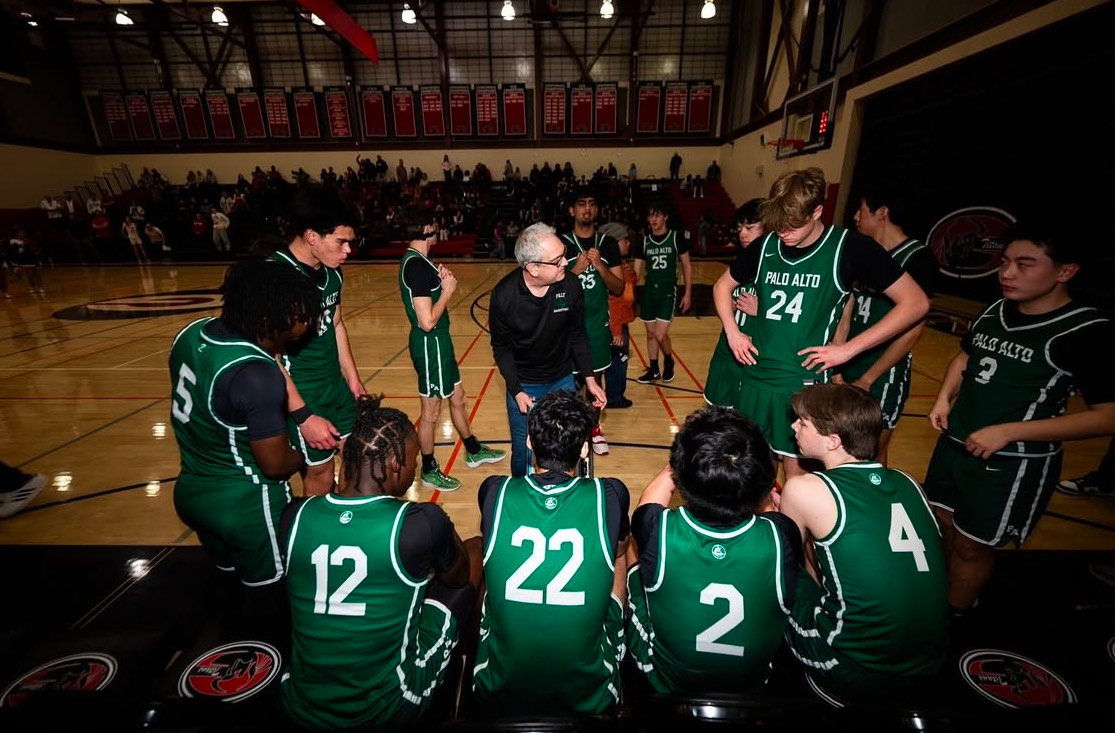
<box><xmin>782</xmin><ymin>384</ymin><xmax>948</xmax><ymax>703</ymax></box>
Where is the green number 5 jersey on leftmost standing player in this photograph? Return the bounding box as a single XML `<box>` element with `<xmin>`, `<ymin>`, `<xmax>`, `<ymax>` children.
<box><xmin>169</xmin><ymin>318</ymin><xmax>282</xmax><ymax>484</ymax></box>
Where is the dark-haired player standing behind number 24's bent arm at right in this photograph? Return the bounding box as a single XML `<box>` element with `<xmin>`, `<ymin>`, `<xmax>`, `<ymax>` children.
<box><xmin>833</xmin><ymin>186</ymin><xmax>938</xmax><ymax>465</ymax></box>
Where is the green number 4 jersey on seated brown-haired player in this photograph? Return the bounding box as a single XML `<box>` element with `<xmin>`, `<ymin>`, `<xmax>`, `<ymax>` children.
<box><xmin>814</xmin><ymin>462</ymin><xmax>948</xmax><ymax>675</ymax></box>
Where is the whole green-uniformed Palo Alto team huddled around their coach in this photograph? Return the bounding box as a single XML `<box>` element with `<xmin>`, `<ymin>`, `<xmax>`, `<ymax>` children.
<box><xmin>169</xmin><ymin>168</ymin><xmax>1115</xmax><ymax>730</ymax></box>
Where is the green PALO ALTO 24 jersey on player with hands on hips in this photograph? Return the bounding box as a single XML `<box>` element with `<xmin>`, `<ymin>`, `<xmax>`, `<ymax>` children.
<box><xmin>744</xmin><ymin>226</ymin><xmax>847</xmax><ymax>392</ymax></box>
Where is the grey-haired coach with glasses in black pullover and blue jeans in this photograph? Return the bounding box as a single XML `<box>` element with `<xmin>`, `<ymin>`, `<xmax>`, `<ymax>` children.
<box><xmin>488</xmin><ymin>223</ymin><xmax>608</xmax><ymax>476</ymax></box>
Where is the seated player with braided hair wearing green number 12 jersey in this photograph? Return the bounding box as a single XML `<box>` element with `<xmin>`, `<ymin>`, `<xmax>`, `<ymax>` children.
<box><xmin>282</xmin><ymin>396</ymin><xmax>481</xmax><ymax>731</ymax></box>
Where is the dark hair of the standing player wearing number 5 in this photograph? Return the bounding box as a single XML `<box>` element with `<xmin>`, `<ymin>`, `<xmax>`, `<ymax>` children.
<box><xmin>221</xmin><ymin>260</ymin><xmax>321</xmax><ymax>344</ymax></box>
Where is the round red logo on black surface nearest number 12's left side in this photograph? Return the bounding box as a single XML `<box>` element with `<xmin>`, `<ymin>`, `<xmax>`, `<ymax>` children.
<box><xmin>178</xmin><ymin>642</ymin><xmax>282</xmax><ymax>703</ymax></box>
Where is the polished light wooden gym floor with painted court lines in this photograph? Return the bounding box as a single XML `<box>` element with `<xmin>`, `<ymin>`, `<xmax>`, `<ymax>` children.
<box><xmin>0</xmin><ymin>253</ymin><xmax>1115</xmax><ymax>550</ymax></box>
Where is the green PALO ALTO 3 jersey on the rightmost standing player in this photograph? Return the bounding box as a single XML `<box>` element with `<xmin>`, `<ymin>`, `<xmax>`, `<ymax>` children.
<box><xmin>948</xmin><ymin>300</ymin><xmax>1107</xmax><ymax>456</ymax></box>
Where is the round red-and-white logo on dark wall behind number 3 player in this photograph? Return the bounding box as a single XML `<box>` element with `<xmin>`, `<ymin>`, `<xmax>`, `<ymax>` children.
<box><xmin>925</xmin><ymin>206</ymin><xmax>1015</xmax><ymax>280</ymax></box>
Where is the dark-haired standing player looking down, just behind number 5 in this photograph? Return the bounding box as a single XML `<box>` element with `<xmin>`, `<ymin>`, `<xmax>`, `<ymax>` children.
<box><xmin>272</xmin><ymin>187</ymin><xmax>367</xmax><ymax>494</ymax></box>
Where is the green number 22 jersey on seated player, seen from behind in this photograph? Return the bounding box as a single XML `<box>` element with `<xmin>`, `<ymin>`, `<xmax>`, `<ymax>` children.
<box><xmin>473</xmin><ymin>476</ymin><xmax>622</xmax><ymax>714</ymax></box>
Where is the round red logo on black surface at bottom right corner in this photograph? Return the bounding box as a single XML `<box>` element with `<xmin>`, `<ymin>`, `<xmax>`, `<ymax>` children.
<box><xmin>960</xmin><ymin>649</ymin><xmax>1076</xmax><ymax>708</ymax></box>
